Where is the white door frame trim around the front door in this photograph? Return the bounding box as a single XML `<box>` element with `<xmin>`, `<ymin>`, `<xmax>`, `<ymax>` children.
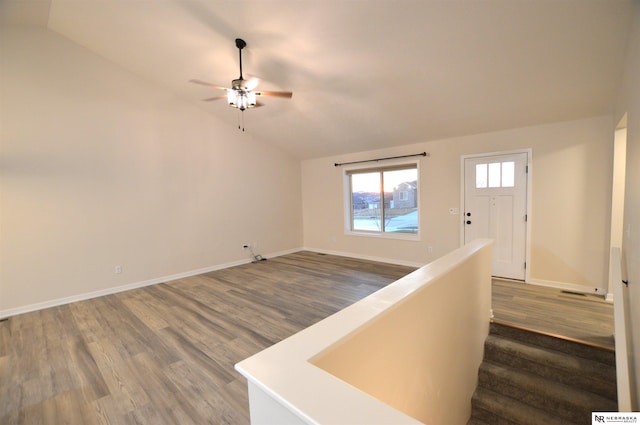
<box><xmin>459</xmin><ymin>148</ymin><xmax>533</xmax><ymax>283</ymax></box>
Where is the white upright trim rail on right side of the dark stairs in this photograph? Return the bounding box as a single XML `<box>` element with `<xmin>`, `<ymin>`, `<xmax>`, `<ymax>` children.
<box><xmin>610</xmin><ymin>247</ymin><xmax>632</xmax><ymax>412</ymax></box>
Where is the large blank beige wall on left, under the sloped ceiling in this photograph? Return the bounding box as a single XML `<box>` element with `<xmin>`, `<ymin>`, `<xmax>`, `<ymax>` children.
<box><xmin>0</xmin><ymin>28</ymin><xmax>302</xmax><ymax>315</ymax></box>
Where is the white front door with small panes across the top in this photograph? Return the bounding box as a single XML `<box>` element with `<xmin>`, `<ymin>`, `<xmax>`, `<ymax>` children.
<box><xmin>463</xmin><ymin>153</ymin><xmax>528</xmax><ymax>280</ymax></box>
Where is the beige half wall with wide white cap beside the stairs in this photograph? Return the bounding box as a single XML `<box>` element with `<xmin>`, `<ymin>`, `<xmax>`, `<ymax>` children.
<box><xmin>235</xmin><ymin>239</ymin><xmax>491</xmax><ymax>425</ymax></box>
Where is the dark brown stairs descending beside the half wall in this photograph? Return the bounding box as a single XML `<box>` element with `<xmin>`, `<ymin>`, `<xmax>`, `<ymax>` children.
<box><xmin>468</xmin><ymin>322</ymin><xmax>618</xmax><ymax>425</ymax></box>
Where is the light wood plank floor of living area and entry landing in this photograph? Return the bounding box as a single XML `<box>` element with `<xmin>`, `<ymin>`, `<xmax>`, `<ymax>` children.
<box><xmin>0</xmin><ymin>252</ymin><xmax>608</xmax><ymax>425</ymax></box>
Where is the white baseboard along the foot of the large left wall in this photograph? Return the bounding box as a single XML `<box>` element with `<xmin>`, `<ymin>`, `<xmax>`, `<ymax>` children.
<box><xmin>0</xmin><ymin>248</ymin><xmax>302</xmax><ymax>319</ymax></box>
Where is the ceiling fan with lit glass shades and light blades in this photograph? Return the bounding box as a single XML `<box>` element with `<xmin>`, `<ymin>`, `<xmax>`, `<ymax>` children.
<box><xmin>189</xmin><ymin>38</ymin><xmax>293</xmax><ymax>111</ymax></box>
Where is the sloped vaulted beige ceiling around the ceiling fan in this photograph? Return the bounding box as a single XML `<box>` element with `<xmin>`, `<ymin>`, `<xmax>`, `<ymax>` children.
<box><xmin>0</xmin><ymin>0</ymin><xmax>633</xmax><ymax>158</ymax></box>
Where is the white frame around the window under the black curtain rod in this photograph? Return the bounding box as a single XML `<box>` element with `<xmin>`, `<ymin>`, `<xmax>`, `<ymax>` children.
<box><xmin>343</xmin><ymin>161</ymin><xmax>422</xmax><ymax>241</ymax></box>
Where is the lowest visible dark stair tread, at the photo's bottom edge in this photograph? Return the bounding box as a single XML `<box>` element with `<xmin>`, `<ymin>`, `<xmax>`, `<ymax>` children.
<box><xmin>470</xmin><ymin>388</ymin><xmax>569</xmax><ymax>425</ymax></box>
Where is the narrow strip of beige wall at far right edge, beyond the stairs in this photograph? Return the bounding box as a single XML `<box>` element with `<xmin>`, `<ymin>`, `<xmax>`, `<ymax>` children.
<box><xmin>611</xmin><ymin>1</ymin><xmax>640</xmax><ymax>410</ymax></box>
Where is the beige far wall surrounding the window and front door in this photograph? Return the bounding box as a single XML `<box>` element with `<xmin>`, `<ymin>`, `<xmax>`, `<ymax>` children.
<box><xmin>302</xmin><ymin>116</ymin><xmax>613</xmax><ymax>291</ymax></box>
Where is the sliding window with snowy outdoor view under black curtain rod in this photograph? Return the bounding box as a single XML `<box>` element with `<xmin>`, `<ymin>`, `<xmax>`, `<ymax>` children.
<box><xmin>346</xmin><ymin>163</ymin><xmax>419</xmax><ymax>235</ymax></box>
